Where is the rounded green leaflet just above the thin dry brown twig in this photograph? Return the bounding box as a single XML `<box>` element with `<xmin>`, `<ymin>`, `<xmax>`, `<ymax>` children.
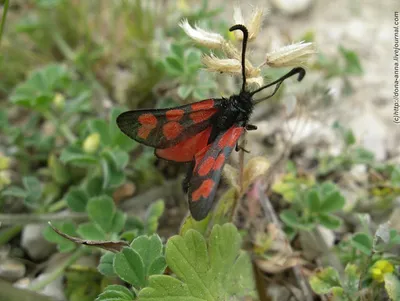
<box><xmin>87</xmin><ymin>195</ymin><xmax>116</xmax><ymax>233</ymax></box>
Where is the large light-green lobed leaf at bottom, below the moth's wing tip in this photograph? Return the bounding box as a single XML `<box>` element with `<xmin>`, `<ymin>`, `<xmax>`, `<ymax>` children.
<box><xmin>139</xmin><ymin>224</ymin><xmax>253</xmax><ymax>301</ymax></box>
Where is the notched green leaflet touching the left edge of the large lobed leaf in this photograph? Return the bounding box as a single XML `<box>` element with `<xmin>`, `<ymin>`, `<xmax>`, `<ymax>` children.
<box><xmin>131</xmin><ymin>234</ymin><xmax>165</xmax><ymax>278</ymax></box>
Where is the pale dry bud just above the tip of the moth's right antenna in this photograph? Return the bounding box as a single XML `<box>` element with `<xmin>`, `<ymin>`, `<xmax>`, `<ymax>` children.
<box><xmin>265</xmin><ymin>41</ymin><xmax>316</xmax><ymax>67</ymax></box>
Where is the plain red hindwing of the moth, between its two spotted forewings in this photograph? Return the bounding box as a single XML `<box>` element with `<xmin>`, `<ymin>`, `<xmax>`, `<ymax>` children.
<box><xmin>156</xmin><ymin>127</ymin><xmax>211</xmax><ymax>162</ymax></box>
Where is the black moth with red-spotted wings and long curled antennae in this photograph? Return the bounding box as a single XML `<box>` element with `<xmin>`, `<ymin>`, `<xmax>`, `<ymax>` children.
<box><xmin>117</xmin><ymin>25</ymin><xmax>305</xmax><ymax>220</ymax></box>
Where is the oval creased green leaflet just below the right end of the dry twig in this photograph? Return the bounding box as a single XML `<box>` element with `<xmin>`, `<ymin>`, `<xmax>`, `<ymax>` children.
<box><xmin>114</xmin><ymin>247</ymin><xmax>146</xmax><ymax>288</ymax></box>
